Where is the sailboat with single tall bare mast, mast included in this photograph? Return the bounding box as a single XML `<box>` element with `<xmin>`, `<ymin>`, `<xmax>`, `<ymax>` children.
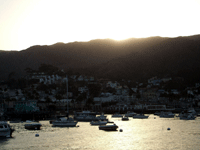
<box><xmin>52</xmin><ymin>78</ymin><xmax>78</xmax><ymax>127</ymax></box>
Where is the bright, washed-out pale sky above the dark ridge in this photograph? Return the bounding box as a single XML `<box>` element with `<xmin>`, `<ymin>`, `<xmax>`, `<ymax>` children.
<box><xmin>0</xmin><ymin>0</ymin><xmax>200</xmax><ymax>50</ymax></box>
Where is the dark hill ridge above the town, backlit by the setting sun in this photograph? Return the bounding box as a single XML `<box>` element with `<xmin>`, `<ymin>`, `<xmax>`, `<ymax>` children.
<box><xmin>0</xmin><ymin>35</ymin><xmax>200</xmax><ymax>84</ymax></box>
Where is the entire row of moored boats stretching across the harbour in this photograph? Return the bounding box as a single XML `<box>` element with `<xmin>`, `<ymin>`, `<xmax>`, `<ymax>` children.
<box><xmin>0</xmin><ymin>110</ymin><xmax>197</xmax><ymax>137</ymax></box>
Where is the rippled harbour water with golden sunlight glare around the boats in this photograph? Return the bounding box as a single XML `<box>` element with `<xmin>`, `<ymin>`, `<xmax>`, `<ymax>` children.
<box><xmin>0</xmin><ymin>115</ymin><xmax>200</xmax><ymax>150</ymax></box>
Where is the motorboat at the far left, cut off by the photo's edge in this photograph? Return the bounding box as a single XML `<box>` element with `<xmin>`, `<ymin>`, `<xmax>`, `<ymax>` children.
<box><xmin>0</xmin><ymin>121</ymin><xmax>15</xmax><ymax>137</ymax></box>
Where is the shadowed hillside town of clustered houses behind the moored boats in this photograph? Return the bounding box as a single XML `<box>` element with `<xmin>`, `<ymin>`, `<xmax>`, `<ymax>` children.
<box><xmin>0</xmin><ymin>73</ymin><xmax>200</xmax><ymax>118</ymax></box>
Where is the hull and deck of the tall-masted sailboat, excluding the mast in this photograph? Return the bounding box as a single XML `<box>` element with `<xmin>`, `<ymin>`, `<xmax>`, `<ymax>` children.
<box><xmin>52</xmin><ymin>117</ymin><xmax>78</xmax><ymax>127</ymax></box>
